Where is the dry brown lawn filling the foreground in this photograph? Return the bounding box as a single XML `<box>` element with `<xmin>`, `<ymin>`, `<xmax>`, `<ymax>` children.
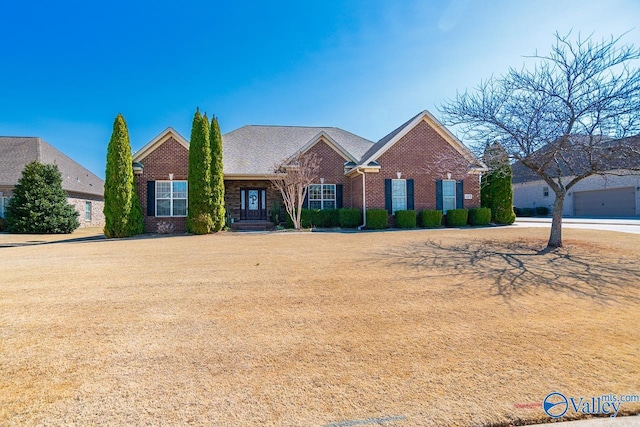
<box><xmin>0</xmin><ymin>228</ymin><xmax>640</xmax><ymax>426</ymax></box>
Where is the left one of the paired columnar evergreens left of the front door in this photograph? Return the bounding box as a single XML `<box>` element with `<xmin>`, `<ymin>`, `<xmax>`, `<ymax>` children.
<box><xmin>187</xmin><ymin>109</ymin><xmax>213</xmax><ymax>234</ymax></box>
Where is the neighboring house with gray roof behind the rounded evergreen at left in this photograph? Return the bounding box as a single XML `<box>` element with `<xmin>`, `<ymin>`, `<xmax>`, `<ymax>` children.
<box><xmin>0</xmin><ymin>137</ymin><xmax>104</xmax><ymax>227</ymax></box>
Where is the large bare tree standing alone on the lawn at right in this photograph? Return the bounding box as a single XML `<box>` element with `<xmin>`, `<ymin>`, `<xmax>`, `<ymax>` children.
<box><xmin>441</xmin><ymin>33</ymin><xmax>640</xmax><ymax>248</ymax></box>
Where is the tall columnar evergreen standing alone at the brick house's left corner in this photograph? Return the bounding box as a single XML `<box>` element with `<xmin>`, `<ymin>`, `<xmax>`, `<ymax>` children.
<box><xmin>103</xmin><ymin>114</ymin><xmax>144</xmax><ymax>238</ymax></box>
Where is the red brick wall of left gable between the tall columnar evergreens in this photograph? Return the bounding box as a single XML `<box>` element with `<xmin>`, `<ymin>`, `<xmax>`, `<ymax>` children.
<box><xmin>135</xmin><ymin>137</ymin><xmax>189</xmax><ymax>233</ymax></box>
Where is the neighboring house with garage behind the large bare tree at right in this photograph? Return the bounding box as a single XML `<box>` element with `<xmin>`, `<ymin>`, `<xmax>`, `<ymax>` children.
<box><xmin>513</xmin><ymin>136</ymin><xmax>640</xmax><ymax>217</ymax></box>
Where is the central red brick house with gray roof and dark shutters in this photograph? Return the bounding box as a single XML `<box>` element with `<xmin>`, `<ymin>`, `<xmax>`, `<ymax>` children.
<box><xmin>133</xmin><ymin>111</ymin><xmax>486</xmax><ymax>232</ymax></box>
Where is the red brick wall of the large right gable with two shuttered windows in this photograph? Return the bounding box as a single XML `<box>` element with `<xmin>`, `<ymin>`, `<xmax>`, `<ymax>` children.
<box><xmin>366</xmin><ymin>121</ymin><xmax>480</xmax><ymax>211</ymax></box>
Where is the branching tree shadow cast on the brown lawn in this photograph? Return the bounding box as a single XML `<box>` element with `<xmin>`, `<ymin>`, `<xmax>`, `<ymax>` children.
<box><xmin>380</xmin><ymin>239</ymin><xmax>640</xmax><ymax>302</ymax></box>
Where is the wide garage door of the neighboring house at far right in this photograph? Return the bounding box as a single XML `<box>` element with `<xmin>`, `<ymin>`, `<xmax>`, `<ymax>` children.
<box><xmin>573</xmin><ymin>187</ymin><xmax>636</xmax><ymax>216</ymax></box>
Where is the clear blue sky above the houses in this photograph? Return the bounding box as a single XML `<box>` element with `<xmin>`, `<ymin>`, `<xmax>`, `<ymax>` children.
<box><xmin>0</xmin><ymin>0</ymin><xmax>640</xmax><ymax>177</ymax></box>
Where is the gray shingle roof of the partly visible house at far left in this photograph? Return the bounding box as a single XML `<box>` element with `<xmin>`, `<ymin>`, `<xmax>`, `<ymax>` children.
<box><xmin>0</xmin><ymin>136</ymin><xmax>104</xmax><ymax>197</ymax></box>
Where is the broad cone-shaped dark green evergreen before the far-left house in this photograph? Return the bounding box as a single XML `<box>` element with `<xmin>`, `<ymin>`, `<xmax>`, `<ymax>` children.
<box><xmin>6</xmin><ymin>162</ymin><xmax>79</xmax><ymax>234</ymax></box>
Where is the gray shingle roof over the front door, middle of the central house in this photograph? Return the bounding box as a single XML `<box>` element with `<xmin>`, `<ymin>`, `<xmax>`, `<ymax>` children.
<box><xmin>222</xmin><ymin>125</ymin><xmax>374</xmax><ymax>175</ymax></box>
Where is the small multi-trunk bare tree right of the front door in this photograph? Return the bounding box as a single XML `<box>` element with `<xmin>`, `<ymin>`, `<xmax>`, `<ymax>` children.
<box><xmin>271</xmin><ymin>153</ymin><xmax>321</xmax><ymax>230</ymax></box>
